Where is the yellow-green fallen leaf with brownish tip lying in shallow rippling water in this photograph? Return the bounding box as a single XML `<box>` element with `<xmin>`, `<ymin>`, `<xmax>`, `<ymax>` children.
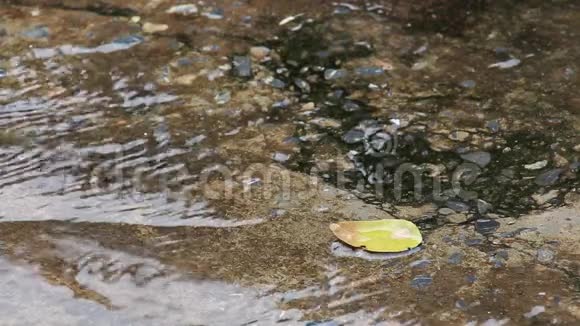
<box><xmin>330</xmin><ymin>219</ymin><xmax>423</xmax><ymax>252</ymax></box>
